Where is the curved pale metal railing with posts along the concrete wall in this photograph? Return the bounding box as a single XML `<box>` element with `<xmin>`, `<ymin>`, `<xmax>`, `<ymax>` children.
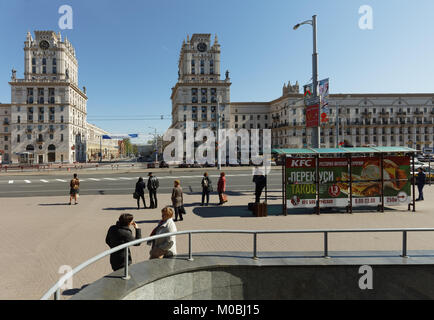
<box><xmin>41</xmin><ymin>228</ymin><xmax>434</xmax><ymax>300</ymax></box>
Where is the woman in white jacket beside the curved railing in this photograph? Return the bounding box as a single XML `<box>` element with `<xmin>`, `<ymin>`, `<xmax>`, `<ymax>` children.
<box><xmin>148</xmin><ymin>207</ymin><xmax>178</xmax><ymax>259</ymax></box>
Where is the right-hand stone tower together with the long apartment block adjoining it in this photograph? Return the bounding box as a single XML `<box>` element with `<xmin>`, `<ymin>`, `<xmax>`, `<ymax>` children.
<box><xmin>171</xmin><ymin>34</ymin><xmax>434</xmax><ymax>156</ymax></box>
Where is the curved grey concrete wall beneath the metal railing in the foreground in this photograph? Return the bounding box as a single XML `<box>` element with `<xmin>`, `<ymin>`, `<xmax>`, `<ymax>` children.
<box><xmin>73</xmin><ymin>252</ymin><xmax>434</xmax><ymax>300</ymax></box>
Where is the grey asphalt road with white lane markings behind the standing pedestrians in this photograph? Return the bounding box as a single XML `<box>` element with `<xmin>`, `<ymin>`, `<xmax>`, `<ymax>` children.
<box><xmin>0</xmin><ymin>169</ymin><xmax>282</xmax><ymax>198</ymax></box>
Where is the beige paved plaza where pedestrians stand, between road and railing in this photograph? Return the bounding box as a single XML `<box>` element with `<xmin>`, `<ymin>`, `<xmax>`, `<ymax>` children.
<box><xmin>0</xmin><ymin>182</ymin><xmax>434</xmax><ymax>299</ymax></box>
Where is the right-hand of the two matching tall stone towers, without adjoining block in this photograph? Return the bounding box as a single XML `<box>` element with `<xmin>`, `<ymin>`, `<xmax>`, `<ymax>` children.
<box><xmin>171</xmin><ymin>33</ymin><xmax>231</xmax><ymax>152</ymax></box>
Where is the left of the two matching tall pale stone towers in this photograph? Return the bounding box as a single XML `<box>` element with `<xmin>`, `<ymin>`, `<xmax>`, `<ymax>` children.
<box><xmin>4</xmin><ymin>31</ymin><xmax>118</xmax><ymax>164</ymax></box>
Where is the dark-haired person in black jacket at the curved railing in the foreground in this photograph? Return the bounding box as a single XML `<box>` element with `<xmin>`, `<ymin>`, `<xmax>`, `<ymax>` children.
<box><xmin>105</xmin><ymin>213</ymin><xmax>142</xmax><ymax>271</ymax></box>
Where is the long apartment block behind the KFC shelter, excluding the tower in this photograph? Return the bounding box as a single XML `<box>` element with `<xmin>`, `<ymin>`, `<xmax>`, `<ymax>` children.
<box><xmin>270</xmin><ymin>94</ymin><xmax>434</xmax><ymax>150</ymax></box>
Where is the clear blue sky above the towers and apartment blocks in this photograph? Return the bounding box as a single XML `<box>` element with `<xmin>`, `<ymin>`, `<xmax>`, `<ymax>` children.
<box><xmin>0</xmin><ymin>0</ymin><xmax>434</xmax><ymax>142</ymax></box>
